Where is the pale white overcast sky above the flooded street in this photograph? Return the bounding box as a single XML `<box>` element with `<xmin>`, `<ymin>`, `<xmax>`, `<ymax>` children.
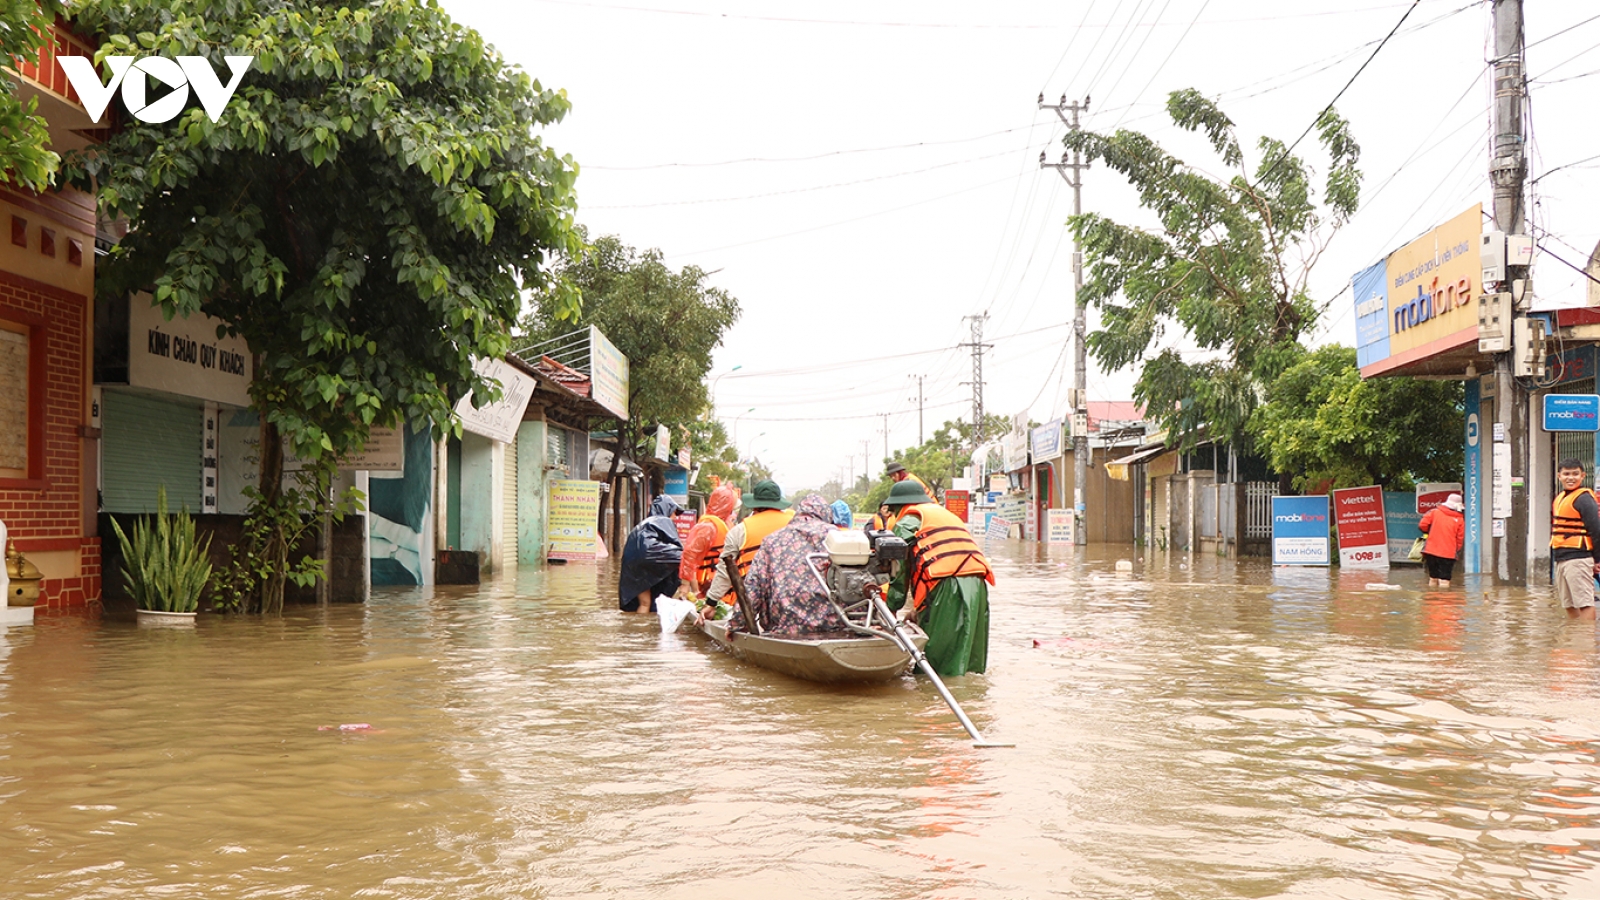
<box><xmin>443</xmin><ymin>0</ymin><xmax>1600</xmax><ymax>490</ymax></box>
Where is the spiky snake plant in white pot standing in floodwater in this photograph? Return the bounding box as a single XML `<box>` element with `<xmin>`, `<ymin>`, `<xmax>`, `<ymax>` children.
<box><xmin>110</xmin><ymin>485</ymin><xmax>211</xmax><ymax>625</ymax></box>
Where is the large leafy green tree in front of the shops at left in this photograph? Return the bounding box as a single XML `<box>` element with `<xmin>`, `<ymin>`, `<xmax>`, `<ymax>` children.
<box><xmin>64</xmin><ymin>0</ymin><xmax>579</xmax><ymax>612</ymax></box>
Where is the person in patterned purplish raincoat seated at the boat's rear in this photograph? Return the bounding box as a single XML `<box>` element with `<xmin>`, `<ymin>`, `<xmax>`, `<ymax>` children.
<box><xmin>728</xmin><ymin>493</ymin><xmax>848</xmax><ymax>637</ymax></box>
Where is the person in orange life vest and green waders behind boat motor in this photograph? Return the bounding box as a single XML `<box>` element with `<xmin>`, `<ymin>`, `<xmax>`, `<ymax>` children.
<box><xmin>883</xmin><ymin>480</ymin><xmax>995</xmax><ymax>676</ymax></box>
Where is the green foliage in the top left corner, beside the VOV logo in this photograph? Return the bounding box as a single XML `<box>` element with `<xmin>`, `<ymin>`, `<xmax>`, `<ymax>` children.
<box><xmin>0</xmin><ymin>0</ymin><xmax>61</xmax><ymax>191</ymax></box>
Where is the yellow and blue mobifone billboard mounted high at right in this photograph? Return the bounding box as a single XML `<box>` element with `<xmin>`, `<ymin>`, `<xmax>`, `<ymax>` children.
<box><xmin>1350</xmin><ymin>203</ymin><xmax>1483</xmax><ymax>378</ymax></box>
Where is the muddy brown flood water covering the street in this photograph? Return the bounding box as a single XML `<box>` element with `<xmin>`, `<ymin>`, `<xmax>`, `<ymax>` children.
<box><xmin>0</xmin><ymin>543</ymin><xmax>1600</xmax><ymax>900</ymax></box>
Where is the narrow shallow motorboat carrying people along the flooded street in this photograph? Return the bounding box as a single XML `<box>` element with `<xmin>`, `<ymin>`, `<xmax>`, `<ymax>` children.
<box><xmin>701</xmin><ymin>620</ymin><xmax>928</xmax><ymax>682</ymax></box>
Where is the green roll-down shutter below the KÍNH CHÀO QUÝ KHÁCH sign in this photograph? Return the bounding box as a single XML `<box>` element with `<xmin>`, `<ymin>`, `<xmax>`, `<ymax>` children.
<box><xmin>101</xmin><ymin>391</ymin><xmax>205</xmax><ymax>512</ymax></box>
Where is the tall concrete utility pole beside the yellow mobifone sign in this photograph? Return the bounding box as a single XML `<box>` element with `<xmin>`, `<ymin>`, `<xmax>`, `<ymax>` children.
<box><xmin>1485</xmin><ymin>0</ymin><xmax>1531</xmax><ymax>585</ymax></box>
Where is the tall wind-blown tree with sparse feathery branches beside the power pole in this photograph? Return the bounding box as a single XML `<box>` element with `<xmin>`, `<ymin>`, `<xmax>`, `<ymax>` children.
<box><xmin>1066</xmin><ymin>90</ymin><xmax>1360</xmax><ymax>445</ymax></box>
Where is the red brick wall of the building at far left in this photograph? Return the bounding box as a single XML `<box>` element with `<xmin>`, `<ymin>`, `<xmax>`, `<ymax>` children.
<box><xmin>0</xmin><ymin>271</ymin><xmax>99</xmax><ymax>607</ymax></box>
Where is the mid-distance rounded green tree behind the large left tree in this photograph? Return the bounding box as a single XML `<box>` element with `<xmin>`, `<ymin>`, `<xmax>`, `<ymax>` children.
<box><xmin>522</xmin><ymin>235</ymin><xmax>739</xmax><ymax>461</ymax></box>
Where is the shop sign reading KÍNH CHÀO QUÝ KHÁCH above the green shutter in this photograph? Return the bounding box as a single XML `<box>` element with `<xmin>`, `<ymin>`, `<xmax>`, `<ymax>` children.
<box><xmin>128</xmin><ymin>293</ymin><xmax>253</xmax><ymax>407</ymax></box>
